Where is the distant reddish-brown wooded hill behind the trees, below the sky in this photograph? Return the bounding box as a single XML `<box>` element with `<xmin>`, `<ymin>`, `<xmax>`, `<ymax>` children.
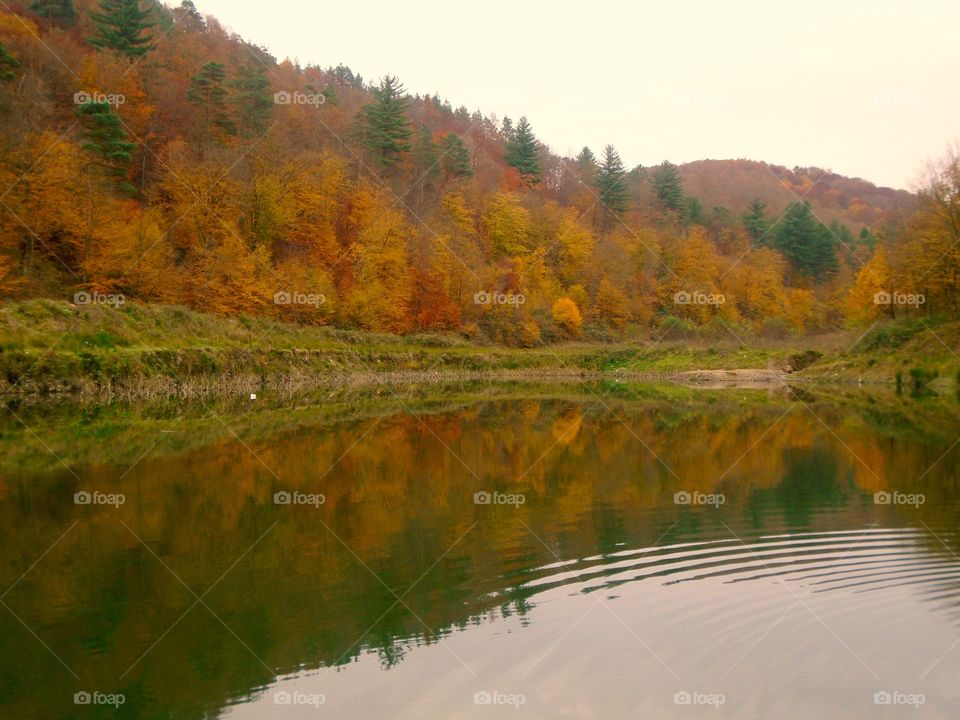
<box><xmin>679</xmin><ymin>160</ymin><xmax>914</xmax><ymax>231</ymax></box>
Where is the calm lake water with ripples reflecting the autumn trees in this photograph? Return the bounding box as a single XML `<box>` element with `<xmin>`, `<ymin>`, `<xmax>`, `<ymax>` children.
<box><xmin>0</xmin><ymin>386</ymin><xmax>960</xmax><ymax>719</ymax></box>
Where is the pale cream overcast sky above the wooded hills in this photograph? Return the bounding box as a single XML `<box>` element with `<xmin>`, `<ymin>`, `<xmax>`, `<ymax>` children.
<box><xmin>191</xmin><ymin>0</ymin><xmax>960</xmax><ymax>189</ymax></box>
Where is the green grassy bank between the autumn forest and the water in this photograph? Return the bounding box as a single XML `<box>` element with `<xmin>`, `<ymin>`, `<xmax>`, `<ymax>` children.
<box><xmin>0</xmin><ymin>300</ymin><xmax>960</xmax><ymax>397</ymax></box>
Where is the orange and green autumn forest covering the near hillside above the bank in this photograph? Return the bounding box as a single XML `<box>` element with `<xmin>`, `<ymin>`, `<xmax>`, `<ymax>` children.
<box><xmin>0</xmin><ymin>0</ymin><xmax>960</xmax><ymax>346</ymax></box>
